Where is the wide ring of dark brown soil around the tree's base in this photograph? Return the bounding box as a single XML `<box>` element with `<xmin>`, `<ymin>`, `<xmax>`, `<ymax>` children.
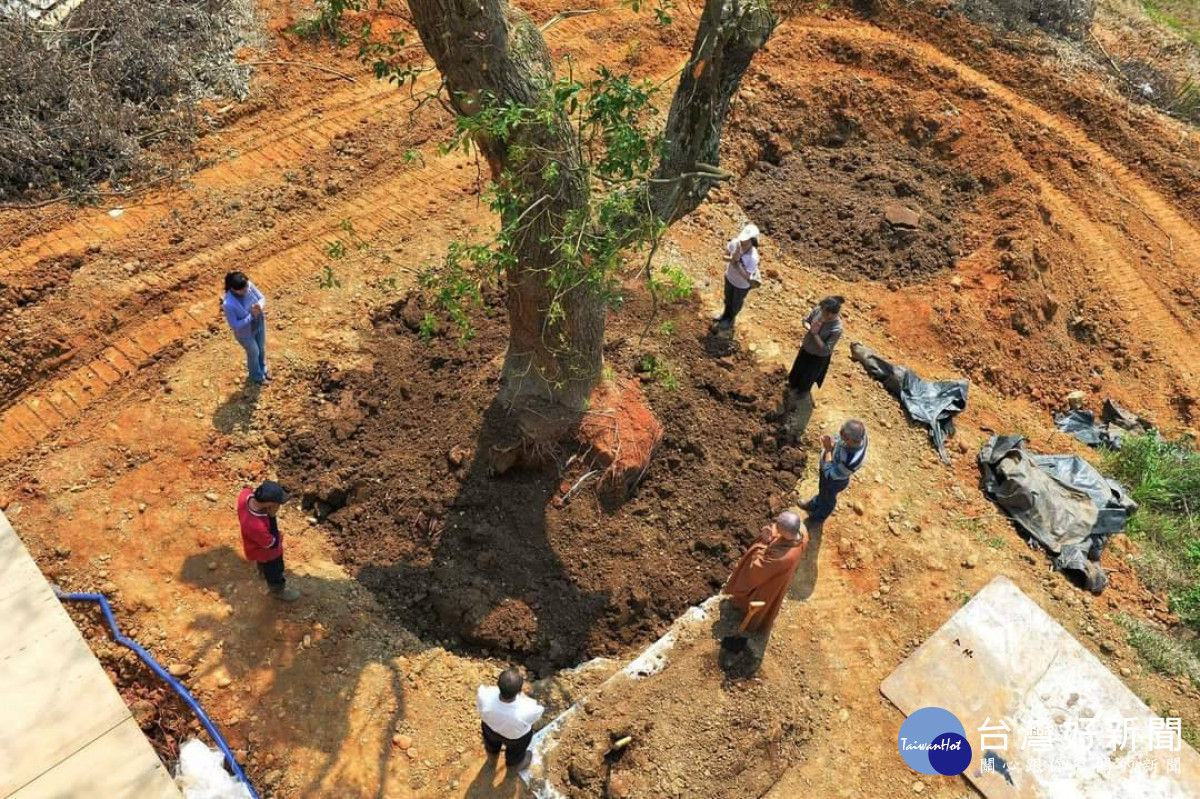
<box><xmin>280</xmin><ymin>286</ymin><xmax>805</xmax><ymax>674</ymax></box>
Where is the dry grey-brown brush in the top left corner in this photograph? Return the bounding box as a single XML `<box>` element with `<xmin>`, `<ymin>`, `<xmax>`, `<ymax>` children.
<box><xmin>0</xmin><ymin>0</ymin><xmax>248</xmax><ymax>199</ymax></box>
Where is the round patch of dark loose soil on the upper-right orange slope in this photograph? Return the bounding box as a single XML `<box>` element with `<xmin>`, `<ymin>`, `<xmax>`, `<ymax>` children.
<box><xmin>740</xmin><ymin>137</ymin><xmax>977</xmax><ymax>282</ymax></box>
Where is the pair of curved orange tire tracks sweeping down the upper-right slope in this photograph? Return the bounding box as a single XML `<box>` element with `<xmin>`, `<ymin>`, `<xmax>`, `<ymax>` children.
<box><xmin>800</xmin><ymin>23</ymin><xmax>1200</xmax><ymax>380</ymax></box>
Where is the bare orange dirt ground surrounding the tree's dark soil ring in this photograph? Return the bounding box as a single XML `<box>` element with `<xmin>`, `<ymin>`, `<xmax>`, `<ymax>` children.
<box><xmin>0</xmin><ymin>6</ymin><xmax>1200</xmax><ymax>797</ymax></box>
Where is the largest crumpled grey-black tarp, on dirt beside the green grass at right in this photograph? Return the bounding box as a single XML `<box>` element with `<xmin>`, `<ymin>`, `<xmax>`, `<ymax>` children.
<box><xmin>979</xmin><ymin>435</ymin><xmax>1138</xmax><ymax>594</ymax></box>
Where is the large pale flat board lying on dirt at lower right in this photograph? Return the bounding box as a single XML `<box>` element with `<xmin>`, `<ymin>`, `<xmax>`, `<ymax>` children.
<box><xmin>880</xmin><ymin>577</ymin><xmax>1200</xmax><ymax>799</ymax></box>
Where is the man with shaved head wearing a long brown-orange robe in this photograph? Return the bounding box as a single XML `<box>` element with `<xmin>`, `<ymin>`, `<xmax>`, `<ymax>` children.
<box><xmin>725</xmin><ymin>511</ymin><xmax>809</xmax><ymax>631</ymax></box>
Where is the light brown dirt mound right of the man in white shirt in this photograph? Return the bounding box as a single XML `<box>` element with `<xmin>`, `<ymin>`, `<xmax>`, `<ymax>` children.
<box><xmin>547</xmin><ymin>609</ymin><xmax>826</xmax><ymax>799</ymax></box>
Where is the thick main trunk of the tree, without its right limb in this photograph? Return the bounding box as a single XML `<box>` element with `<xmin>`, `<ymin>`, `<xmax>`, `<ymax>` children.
<box><xmin>409</xmin><ymin>0</ymin><xmax>605</xmax><ymax>410</ymax></box>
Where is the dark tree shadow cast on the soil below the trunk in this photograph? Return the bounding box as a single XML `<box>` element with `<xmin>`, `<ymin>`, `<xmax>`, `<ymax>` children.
<box><xmin>356</xmin><ymin>401</ymin><xmax>613</xmax><ymax>675</ymax></box>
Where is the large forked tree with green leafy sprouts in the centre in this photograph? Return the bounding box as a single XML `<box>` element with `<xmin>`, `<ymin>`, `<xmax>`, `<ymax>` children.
<box><xmin>408</xmin><ymin>0</ymin><xmax>776</xmax><ymax>422</ymax></box>
